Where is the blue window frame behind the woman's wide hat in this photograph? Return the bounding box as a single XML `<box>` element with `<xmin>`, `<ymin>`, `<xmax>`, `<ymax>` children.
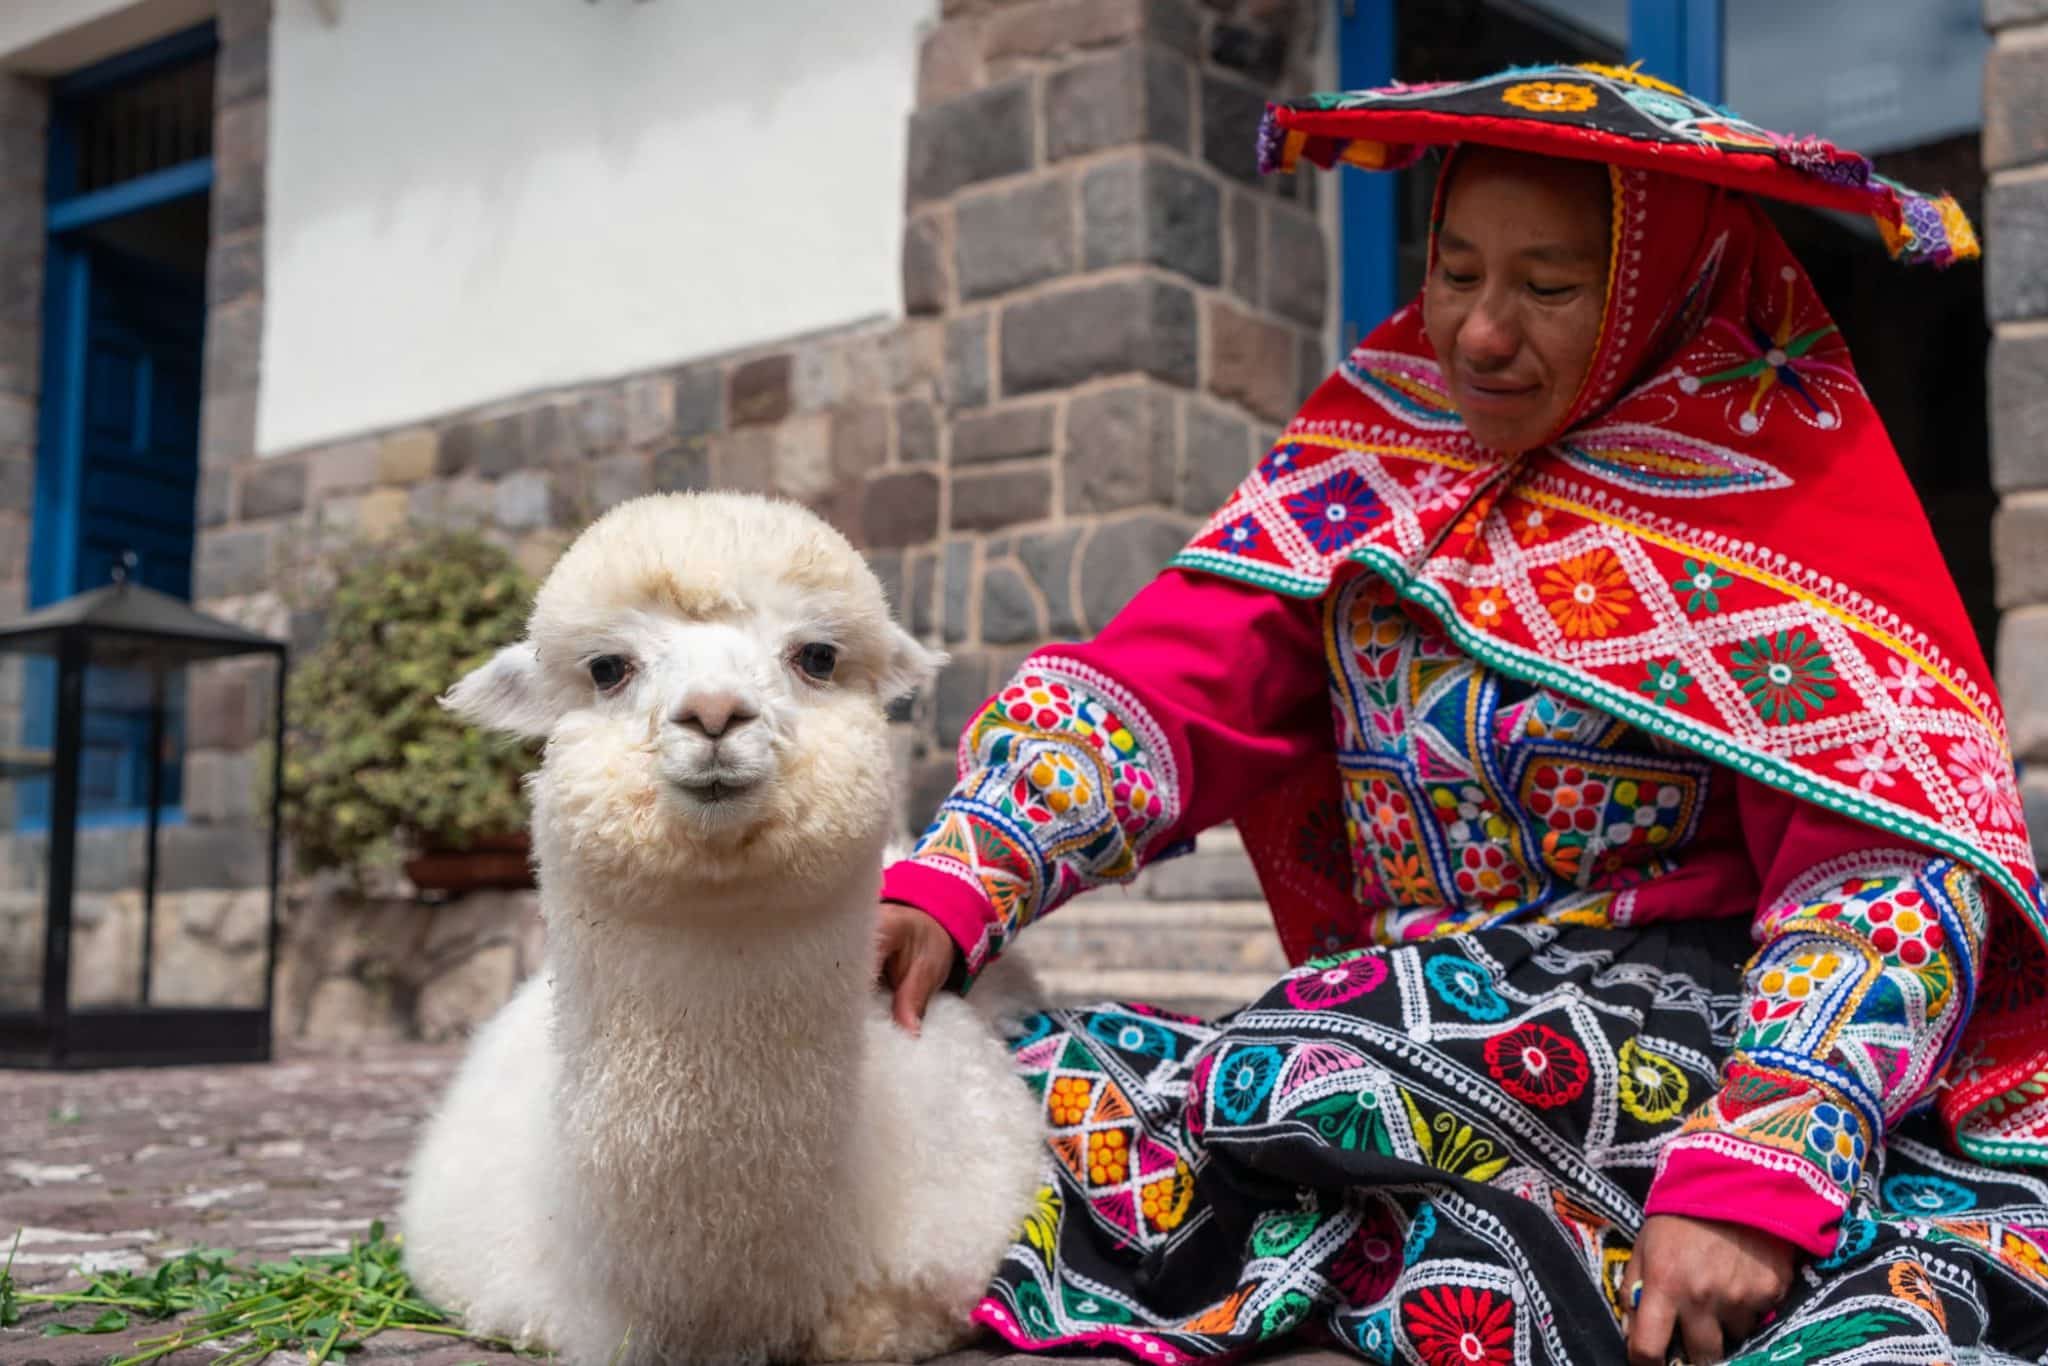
<box><xmin>1335</xmin><ymin>0</ymin><xmax>1724</xmax><ymax>350</ymax></box>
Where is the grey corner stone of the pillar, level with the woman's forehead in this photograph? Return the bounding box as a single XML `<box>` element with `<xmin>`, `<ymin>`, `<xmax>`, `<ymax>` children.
<box><xmin>1081</xmin><ymin>156</ymin><xmax>1223</xmax><ymax>285</ymax></box>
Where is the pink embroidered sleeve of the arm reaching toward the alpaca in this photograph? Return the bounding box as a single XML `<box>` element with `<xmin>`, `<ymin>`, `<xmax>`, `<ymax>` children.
<box><xmin>883</xmin><ymin>569</ymin><xmax>1333</xmax><ymax>977</ymax></box>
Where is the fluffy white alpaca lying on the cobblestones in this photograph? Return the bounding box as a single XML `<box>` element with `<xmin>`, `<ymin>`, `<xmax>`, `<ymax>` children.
<box><xmin>401</xmin><ymin>494</ymin><xmax>1040</xmax><ymax>1366</ymax></box>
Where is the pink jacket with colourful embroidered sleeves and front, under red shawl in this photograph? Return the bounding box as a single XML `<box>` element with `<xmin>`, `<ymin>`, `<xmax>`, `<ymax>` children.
<box><xmin>883</xmin><ymin>571</ymin><xmax>1987</xmax><ymax>1255</ymax></box>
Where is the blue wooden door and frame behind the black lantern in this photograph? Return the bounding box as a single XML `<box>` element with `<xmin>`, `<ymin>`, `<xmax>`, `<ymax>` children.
<box><xmin>16</xmin><ymin>25</ymin><xmax>217</xmax><ymax>829</ymax></box>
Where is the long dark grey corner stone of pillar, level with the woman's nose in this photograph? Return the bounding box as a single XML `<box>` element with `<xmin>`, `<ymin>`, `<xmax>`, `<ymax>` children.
<box><xmin>1001</xmin><ymin>279</ymin><xmax>1196</xmax><ymax>395</ymax></box>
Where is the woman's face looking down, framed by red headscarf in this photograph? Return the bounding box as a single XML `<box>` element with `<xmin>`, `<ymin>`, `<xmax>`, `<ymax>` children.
<box><xmin>1423</xmin><ymin>147</ymin><xmax>1610</xmax><ymax>455</ymax></box>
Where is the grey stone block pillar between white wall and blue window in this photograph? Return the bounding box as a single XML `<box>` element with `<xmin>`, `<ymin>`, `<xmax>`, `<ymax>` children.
<box><xmin>903</xmin><ymin>0</ymin><xmax>1329</xmax><ymax>813</ymax></box>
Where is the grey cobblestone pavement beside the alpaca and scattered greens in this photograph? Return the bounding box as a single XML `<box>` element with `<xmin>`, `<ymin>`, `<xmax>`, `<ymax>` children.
<box><xmin>0</xmin><ymin>1047</ymin><xmax>1337</xmax><ymax>1366</ymax></box>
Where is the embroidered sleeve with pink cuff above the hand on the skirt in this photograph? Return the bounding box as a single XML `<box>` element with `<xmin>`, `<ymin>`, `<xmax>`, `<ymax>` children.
<box><xmin>1645</xmin><ymin>780</ymin><xmax>1989</xmax><ymax>1255</ymax></box>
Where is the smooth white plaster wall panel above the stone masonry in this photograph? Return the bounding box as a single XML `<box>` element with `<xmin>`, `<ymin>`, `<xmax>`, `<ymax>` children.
<box><xmin>258</xmin><ymin>0</ymin><xmax>936</xmax><ymax>453</ymax></box>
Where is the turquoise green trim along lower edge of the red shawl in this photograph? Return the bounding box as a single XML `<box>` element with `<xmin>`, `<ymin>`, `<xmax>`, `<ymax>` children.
<box><xmin>1174</xmin><ymin>545</ymin><xmax>2048</xmax><ymax>940</ymax></box>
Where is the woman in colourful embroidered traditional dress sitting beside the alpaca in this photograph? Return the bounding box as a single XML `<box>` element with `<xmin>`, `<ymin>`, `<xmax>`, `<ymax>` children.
<box><xmin>883</xmin><ymin>68</ymin><xmax>2048</xmax><ymax>1364</ymax></box>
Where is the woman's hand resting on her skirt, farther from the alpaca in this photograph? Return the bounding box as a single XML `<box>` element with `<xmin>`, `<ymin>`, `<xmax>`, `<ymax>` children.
<box><xmin>1622</xmin><ymin>1214</ymin><xmax>1798</xmax><ymax>1366</ymax></box>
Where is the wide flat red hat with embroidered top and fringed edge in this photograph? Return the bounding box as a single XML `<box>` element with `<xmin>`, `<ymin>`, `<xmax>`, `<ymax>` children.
<box><xmin>1260</xmin><ymin>61</ymin><xmax>1978</xmax><ymax>266</ymax></box>
